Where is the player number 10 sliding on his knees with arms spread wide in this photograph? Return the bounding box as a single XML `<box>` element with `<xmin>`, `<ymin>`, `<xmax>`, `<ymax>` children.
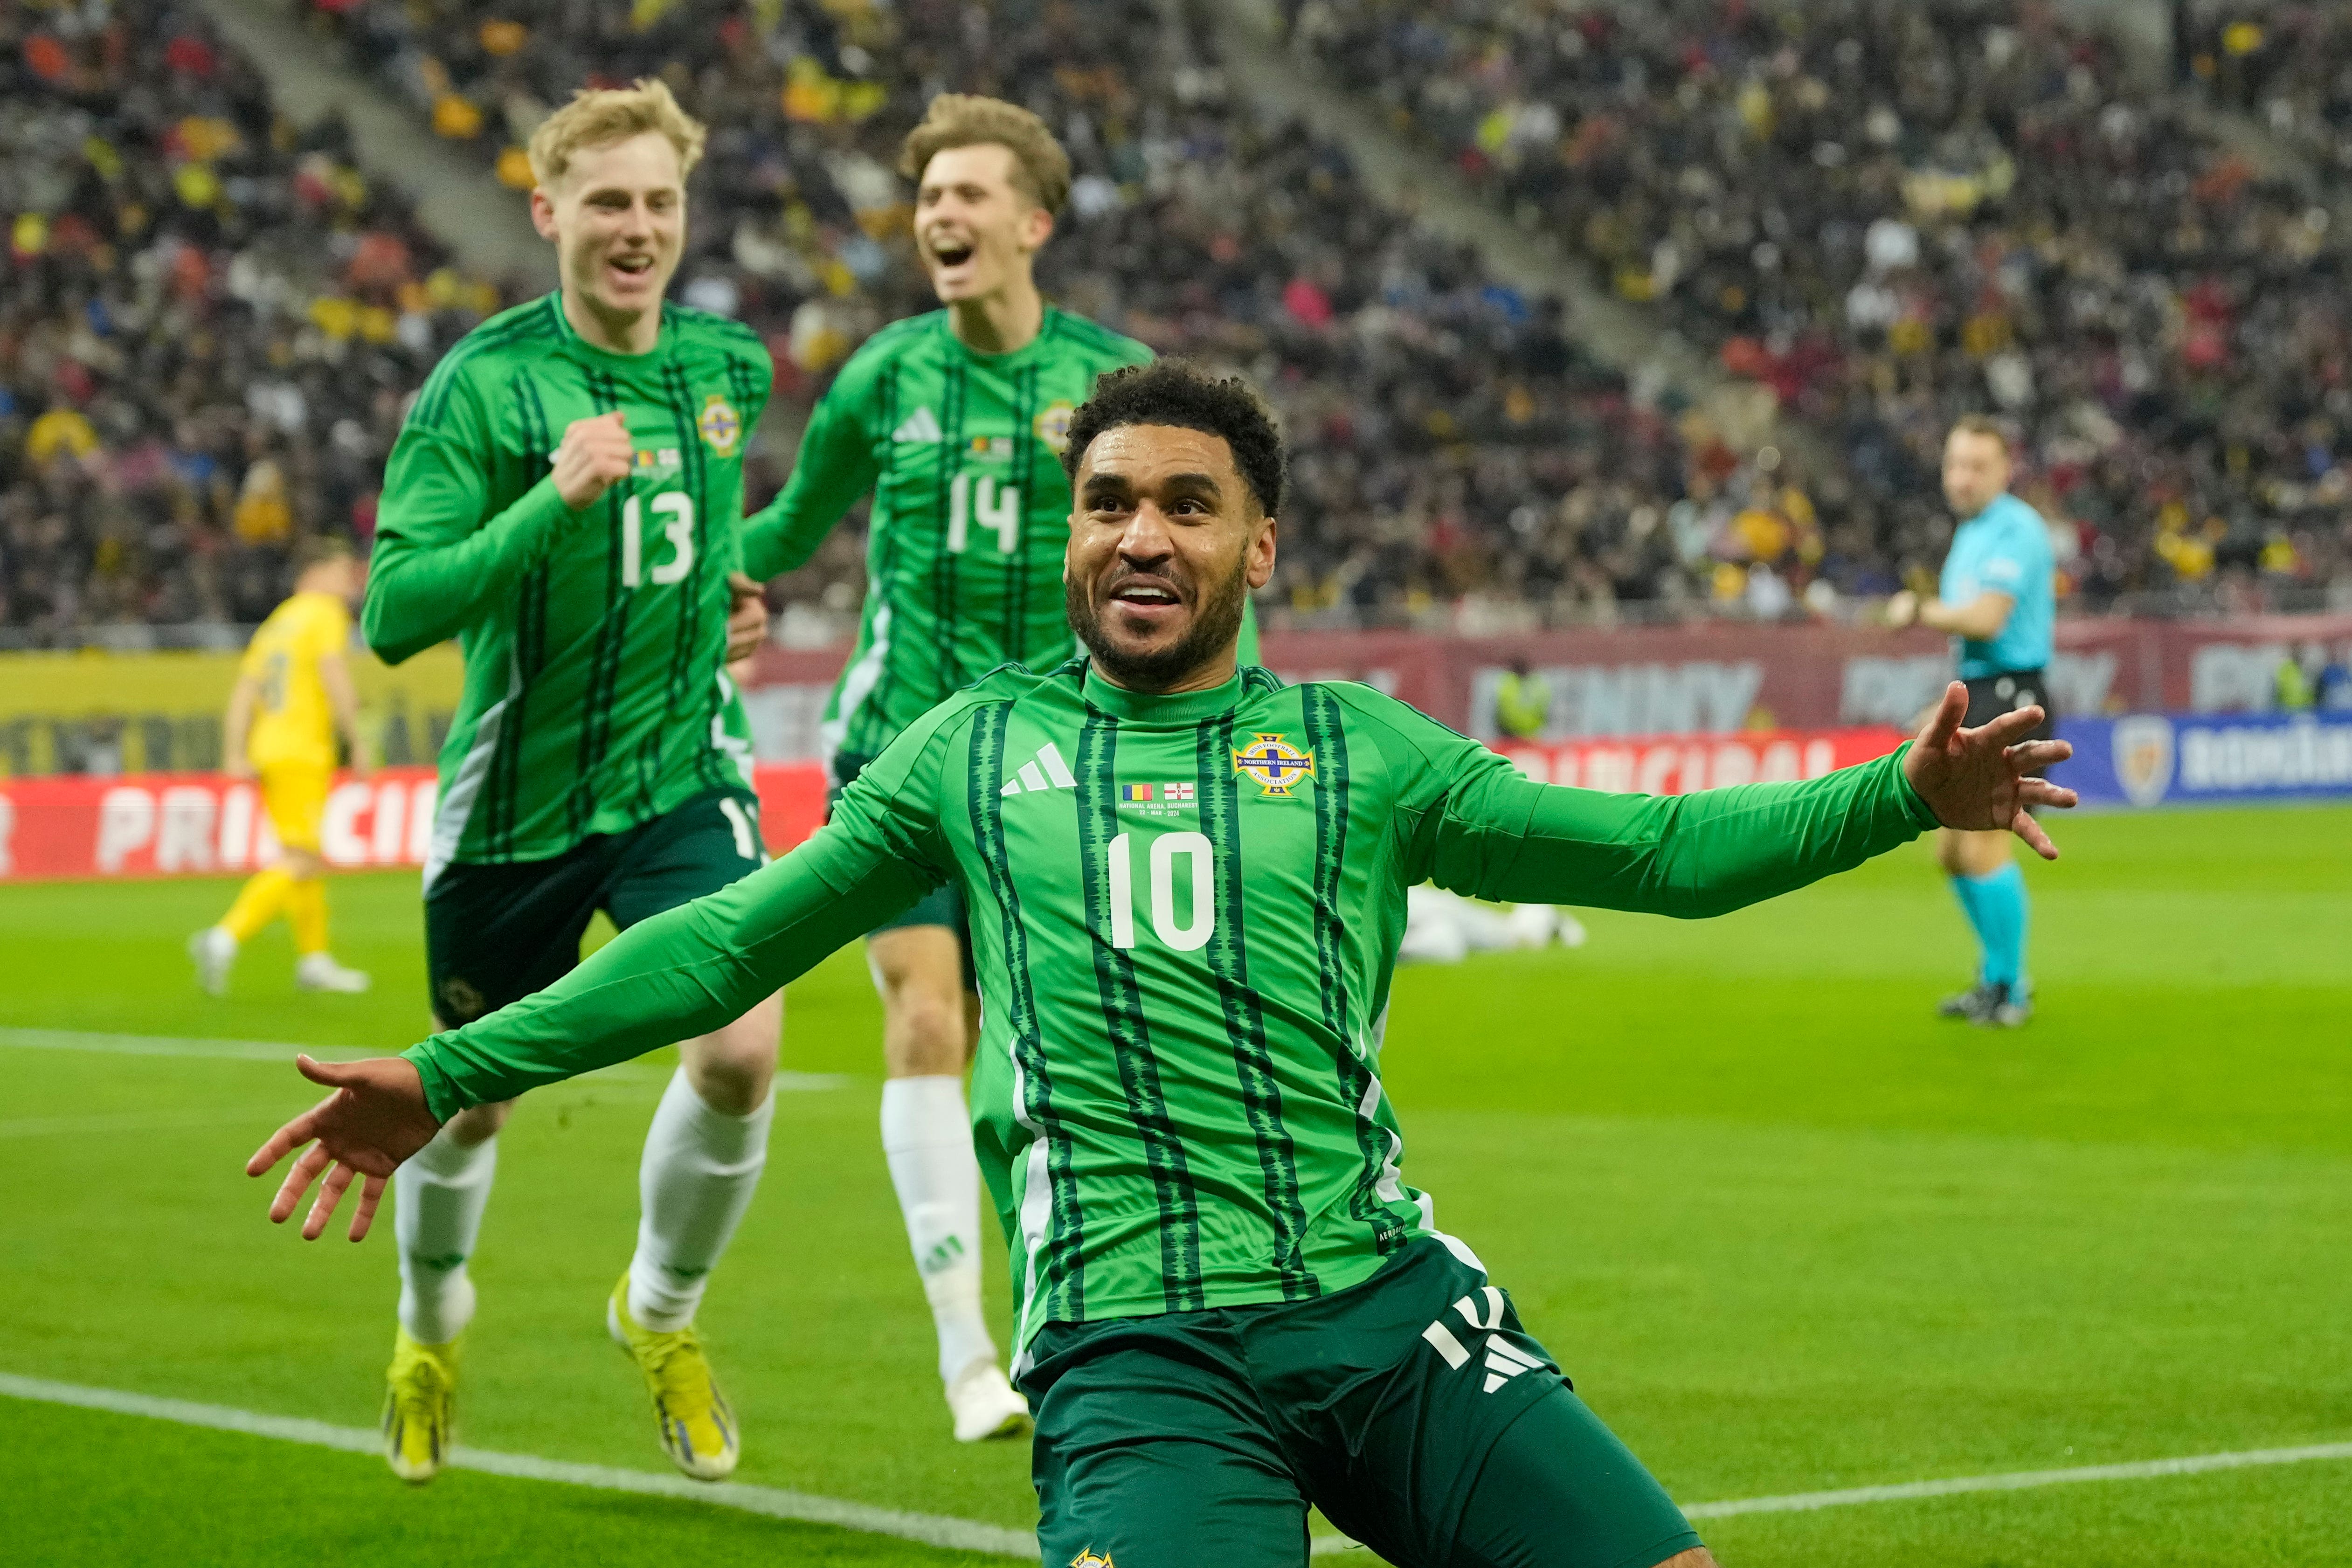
<box><xmin>247</xmin><ymin>362</ymin><xmax>2075</xmax><ymax>1568</ymax></box>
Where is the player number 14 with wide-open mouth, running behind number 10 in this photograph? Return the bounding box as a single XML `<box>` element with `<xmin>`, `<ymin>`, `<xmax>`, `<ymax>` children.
<box><xmin>746</xmin><ymin>94</ymin><xmax>1256</xmax><ymax>1444</ymax></box>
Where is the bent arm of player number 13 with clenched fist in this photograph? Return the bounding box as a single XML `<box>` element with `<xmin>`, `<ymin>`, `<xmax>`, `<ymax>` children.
<box><xmin>360</xmin><ymin>404</ymin><xmax>633</xmax><ymax>665</ymax></box>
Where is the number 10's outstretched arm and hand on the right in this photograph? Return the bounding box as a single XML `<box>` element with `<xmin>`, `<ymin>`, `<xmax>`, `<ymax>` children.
<box><xmin>1425</xmin><ymin>682</ymin><xmax>2075</xmax><ymax>919</ymax></box>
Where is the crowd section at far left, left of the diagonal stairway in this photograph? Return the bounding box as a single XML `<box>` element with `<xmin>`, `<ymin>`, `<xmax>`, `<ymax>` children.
<box><xmin>0</xmin><ymin>0</ymin><xmax>512</xmax><ymax>647</ymax></box>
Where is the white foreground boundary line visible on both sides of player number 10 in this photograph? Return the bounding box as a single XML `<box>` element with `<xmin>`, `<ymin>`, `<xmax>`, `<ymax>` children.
<box><xmin>0</xmin><ymin>1373</ymin><xmax>2352</xmax><ymax>1559</ymax></box>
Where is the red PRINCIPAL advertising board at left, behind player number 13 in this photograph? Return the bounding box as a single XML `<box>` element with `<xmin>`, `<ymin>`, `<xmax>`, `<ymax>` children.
<box><xmin>0</xmin><ymin>762</ymin><xmax>825</xmax><ymax>882</ymax></box>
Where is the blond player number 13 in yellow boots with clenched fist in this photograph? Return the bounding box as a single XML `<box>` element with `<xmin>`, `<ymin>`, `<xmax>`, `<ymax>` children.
<box><xmin>362</xmin><ymin>82</ymin><xmax>783</xmax><ymax>1481</ymax></box>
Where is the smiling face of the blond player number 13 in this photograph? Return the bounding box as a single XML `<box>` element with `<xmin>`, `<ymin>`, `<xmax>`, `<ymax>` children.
<box><xmin>532</xmin><ymin>131</ymin><xmax>687</xmax><ymax>333</ymax></box>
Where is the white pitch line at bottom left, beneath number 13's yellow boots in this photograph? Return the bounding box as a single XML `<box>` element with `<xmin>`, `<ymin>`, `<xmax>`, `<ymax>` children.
<box><xmin>0</xmin><ymin>1373</ymin><xmax>1037</xmax><ymax>1561</ymax></box>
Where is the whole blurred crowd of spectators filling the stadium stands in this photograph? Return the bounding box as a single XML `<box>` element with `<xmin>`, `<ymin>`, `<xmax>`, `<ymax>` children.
<box><xmin>18</xmin><ymin>0</ymin><xmax>2352</xmax><ymax>644</ymax></box>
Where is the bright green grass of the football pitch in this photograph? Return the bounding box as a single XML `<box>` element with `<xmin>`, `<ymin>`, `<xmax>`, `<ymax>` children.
<box><xmin>0</xmin><ymin>808</ymin><xmax>2352</xmax><ymax>1568</ymax></box>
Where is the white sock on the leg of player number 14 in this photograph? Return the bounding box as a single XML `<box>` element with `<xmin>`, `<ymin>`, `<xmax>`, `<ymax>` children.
<box><xmin>882</xmin><ymin>1074</ymin><xmax>997</xmax><ymax>1380</ymax></box>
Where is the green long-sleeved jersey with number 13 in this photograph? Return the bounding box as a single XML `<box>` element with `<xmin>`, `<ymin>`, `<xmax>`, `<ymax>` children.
<box><xmin>362</xmin><ymin>294</ymin><xmax>771</xmax><ymax>886</ymax></box>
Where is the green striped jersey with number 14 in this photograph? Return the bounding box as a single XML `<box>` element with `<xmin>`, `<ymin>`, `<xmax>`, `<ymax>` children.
<box><xmin>746</xmin><ymin>305</ymin><xmax>1153</xmax><ymax>760</ymax></box>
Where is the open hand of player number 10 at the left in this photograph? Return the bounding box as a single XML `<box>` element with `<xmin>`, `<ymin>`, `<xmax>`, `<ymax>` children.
<box><xmin>245</xmin><ymin>1056</ymin><xmax>440</xmax><ymax>1241</ymax></box>
